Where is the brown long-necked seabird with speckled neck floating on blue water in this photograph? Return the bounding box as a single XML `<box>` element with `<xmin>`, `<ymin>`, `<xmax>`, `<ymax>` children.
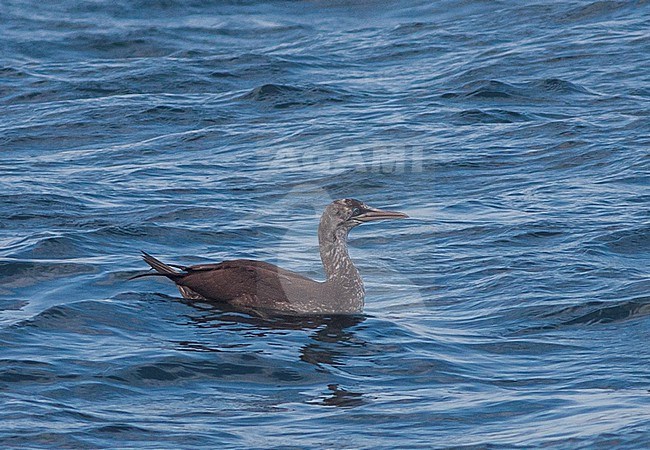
<box><xmin>133</xmin><ymin>199</ymin><xmax>408</xmax><ymax>315</ymax></box>
